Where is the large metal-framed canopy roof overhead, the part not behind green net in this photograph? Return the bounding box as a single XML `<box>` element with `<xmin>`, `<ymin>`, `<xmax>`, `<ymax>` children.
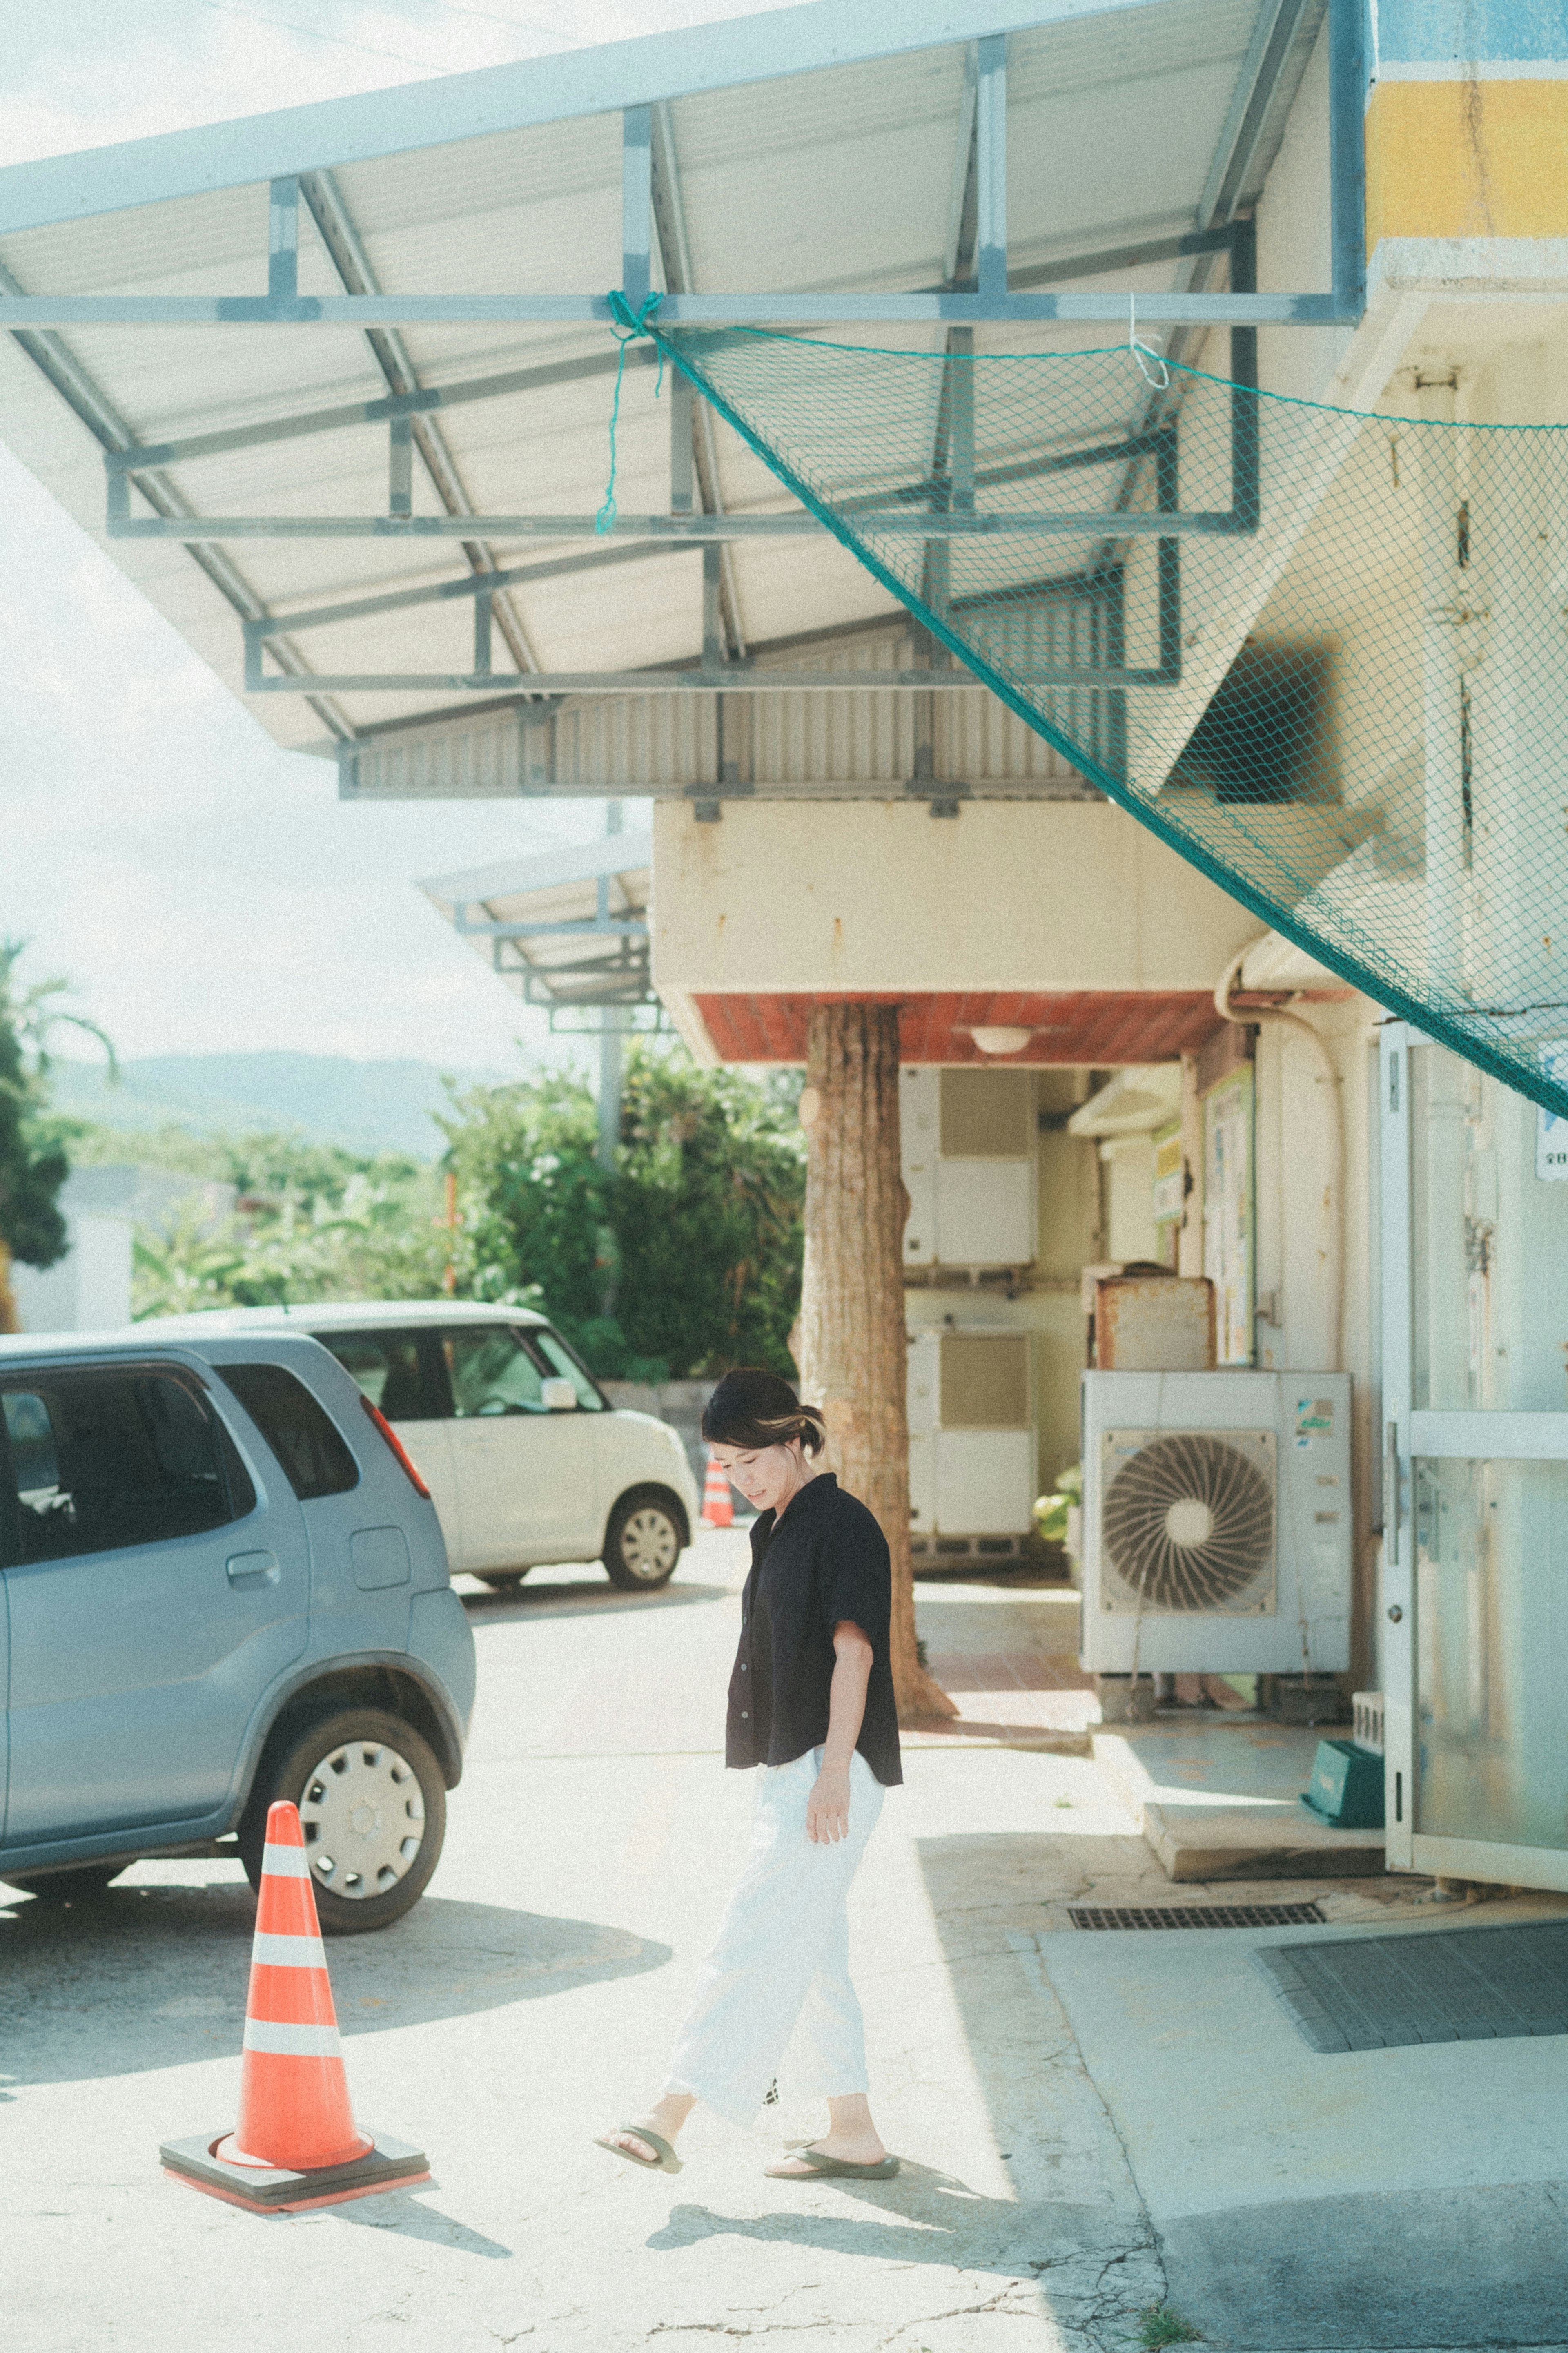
<box><xmin>0</xmin><ymin>0</ymin><xmax>1361</xmax><ymax>800</ymax></box>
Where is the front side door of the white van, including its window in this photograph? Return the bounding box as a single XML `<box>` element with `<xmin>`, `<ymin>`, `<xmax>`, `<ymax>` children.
<box><xmin>440</xmin><ymin>1325</ymin><xmax>604</xmax><ymax>1570</ymax></box>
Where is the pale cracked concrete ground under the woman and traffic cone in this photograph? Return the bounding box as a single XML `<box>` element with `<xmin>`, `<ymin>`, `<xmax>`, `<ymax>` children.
<box><xmin>0</xmin><ymin>1534</ymin><xmax>1568</xmax><ymax>2353</ymax></box>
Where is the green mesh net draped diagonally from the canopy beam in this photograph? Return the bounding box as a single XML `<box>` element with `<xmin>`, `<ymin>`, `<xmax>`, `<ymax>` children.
<box><xmin>646</xmin><ymin>322</ymin><xmax>1568</xmax><ymax>1115</ymax></box>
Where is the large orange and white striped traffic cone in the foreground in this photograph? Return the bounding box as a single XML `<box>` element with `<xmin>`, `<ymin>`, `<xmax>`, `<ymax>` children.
<box><xmin>160</xmin><ymin>1805</ymin><xmax>430</xmax><ymax>2214</ymax></box>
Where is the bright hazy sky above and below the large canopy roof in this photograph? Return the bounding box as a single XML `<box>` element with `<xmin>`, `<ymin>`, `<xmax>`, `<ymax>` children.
<box><xmin>0</xmin><ymin>0</ymin><xmax>785</xmax><ymax>1066</ymax></box>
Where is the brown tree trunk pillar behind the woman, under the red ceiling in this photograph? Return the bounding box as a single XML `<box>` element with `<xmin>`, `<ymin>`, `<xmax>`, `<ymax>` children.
<box><xmin>799</xmin><ymin>1000</ymin><xmax>959</xmax><ymax>1725</ymax></box>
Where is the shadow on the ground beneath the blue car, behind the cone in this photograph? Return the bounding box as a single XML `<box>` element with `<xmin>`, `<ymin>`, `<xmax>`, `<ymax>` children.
<box><xmin>0</xmin><ymin>1878</ymin><xmax>670</xmax><ymax>2082</ymax></box>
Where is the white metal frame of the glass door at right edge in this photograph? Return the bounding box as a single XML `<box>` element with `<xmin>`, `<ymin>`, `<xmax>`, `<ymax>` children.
<box><xmin>1378</xmin><ymin>1021</ymin><xmax>1568</xmax><ymax>1892</ymax></box>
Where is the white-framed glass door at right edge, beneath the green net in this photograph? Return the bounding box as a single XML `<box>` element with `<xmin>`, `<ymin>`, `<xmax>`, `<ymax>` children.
<box><xmin>1378</xmin><ymin>1024</ymin><xmax>1568</xmax><ymax>1889</ymax></box>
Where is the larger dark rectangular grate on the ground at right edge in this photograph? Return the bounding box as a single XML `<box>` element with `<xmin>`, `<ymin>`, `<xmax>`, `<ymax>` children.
<box><xmin>1253</xmin><ymin>1920</ymin><xmax>1568</xmax><ymax>2052</ymax></box>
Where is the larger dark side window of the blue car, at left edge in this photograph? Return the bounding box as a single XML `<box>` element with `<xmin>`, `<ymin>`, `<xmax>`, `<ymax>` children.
<box><xmin>0</xmin><ymin>1369</ymin><xmax>245</xmax><ymax>1565</ymax></box>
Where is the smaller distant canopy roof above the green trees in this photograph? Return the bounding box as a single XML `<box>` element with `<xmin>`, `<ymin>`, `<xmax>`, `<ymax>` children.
<box><xmin>421</xmin><ymin>833</ymin><xmax>658</xmax><ymax>1028</ymax></box>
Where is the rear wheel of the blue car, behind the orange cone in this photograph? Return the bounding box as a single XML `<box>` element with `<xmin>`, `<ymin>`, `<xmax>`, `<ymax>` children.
<box><xmin>240</xmin><ymin>1708</ymin><xmax>447</xmax><ymax>1936</ymax></box>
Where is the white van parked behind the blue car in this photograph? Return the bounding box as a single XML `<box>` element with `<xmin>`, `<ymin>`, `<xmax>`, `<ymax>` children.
<box><xmin>146</xmin><ymin>1299</ymin><xmax>701</xmax><ymax>1593</ymax></box>
